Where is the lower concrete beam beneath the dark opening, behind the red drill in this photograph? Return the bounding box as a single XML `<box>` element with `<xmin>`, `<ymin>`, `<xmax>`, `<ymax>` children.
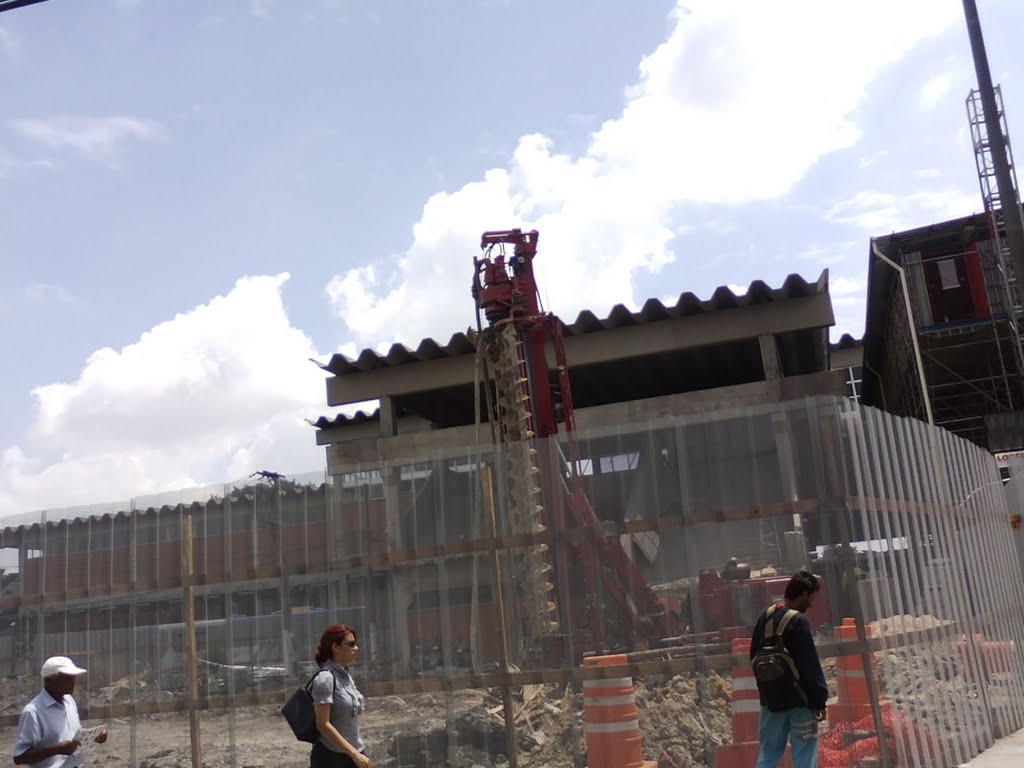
<box><xmin>327</xmin><ymin>371</ymin><xmax>846</xmax><ymax>475</ymax></box>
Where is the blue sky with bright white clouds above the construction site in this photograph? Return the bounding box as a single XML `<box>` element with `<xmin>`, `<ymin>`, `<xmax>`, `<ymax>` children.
<box><xmin>0</xmin><ymin>0</ymin><xmax>1024</xmax><ymax>517</ymax></box>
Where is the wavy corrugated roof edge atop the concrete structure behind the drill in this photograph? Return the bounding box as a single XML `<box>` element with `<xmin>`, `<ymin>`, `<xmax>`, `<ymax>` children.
<box><xmin>316</xmin><ymin>269</ymin><xmax>828</xmax><ymax>378</ymax></box>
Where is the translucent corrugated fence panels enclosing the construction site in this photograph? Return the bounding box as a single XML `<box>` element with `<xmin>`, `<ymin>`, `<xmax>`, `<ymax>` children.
<box><xmin>0</xmin><ymin>398</ymin><xmax>1024</xmax><ymax>768</ymax></box>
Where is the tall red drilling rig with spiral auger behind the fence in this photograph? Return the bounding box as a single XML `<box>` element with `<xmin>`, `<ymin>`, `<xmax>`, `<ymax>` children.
<box><xmin>472</xmin><ymin>229</ymin><xmax>679</xmax><ymax>655</ymax></box>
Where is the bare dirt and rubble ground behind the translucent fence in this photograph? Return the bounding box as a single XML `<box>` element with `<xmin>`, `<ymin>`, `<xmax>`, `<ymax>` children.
<box><xmin>0</xmin><ymin>616</ymin><xmax>981</xmax><ymax>768</ymax></box>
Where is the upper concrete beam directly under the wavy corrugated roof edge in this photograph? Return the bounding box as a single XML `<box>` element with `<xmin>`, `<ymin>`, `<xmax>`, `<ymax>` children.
<box><xmin>327</xmin><ymin>294</ymin><xmax>836</xmax><ymax>406</ymax></box>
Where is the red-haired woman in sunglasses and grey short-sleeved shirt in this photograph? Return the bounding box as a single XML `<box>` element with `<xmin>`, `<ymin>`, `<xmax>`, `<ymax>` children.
<box><xmin>309</xmin><ymin>624</ymin><xmax>373</xmax><ymax>768</ymax></box>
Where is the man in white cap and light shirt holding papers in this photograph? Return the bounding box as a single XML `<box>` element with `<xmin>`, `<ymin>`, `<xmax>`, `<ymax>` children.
<box><xmin>14</xmin><ymin>656</ymin><xmax>106</xmax><ymax>768</ymax></box>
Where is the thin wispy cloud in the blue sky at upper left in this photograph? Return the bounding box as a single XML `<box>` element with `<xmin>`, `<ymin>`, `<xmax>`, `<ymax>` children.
<box><xmin>10</xmin><ymin>115</ymin><xmax>165</xmax><ymax>166</ymax></box>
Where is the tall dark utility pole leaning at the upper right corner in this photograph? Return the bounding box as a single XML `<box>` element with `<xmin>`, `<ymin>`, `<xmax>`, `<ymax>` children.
<box><xmin>964</xmin><ymin>0</ymin><xmax>1024</xmax><ymax>288</ymax></box>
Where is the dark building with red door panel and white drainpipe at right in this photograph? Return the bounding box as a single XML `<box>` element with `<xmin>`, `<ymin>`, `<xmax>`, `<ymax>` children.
<box><xmin>863</xmin><ymin>214</ymin><xmax>1024</xmax><ymax>452</ymax></box>
